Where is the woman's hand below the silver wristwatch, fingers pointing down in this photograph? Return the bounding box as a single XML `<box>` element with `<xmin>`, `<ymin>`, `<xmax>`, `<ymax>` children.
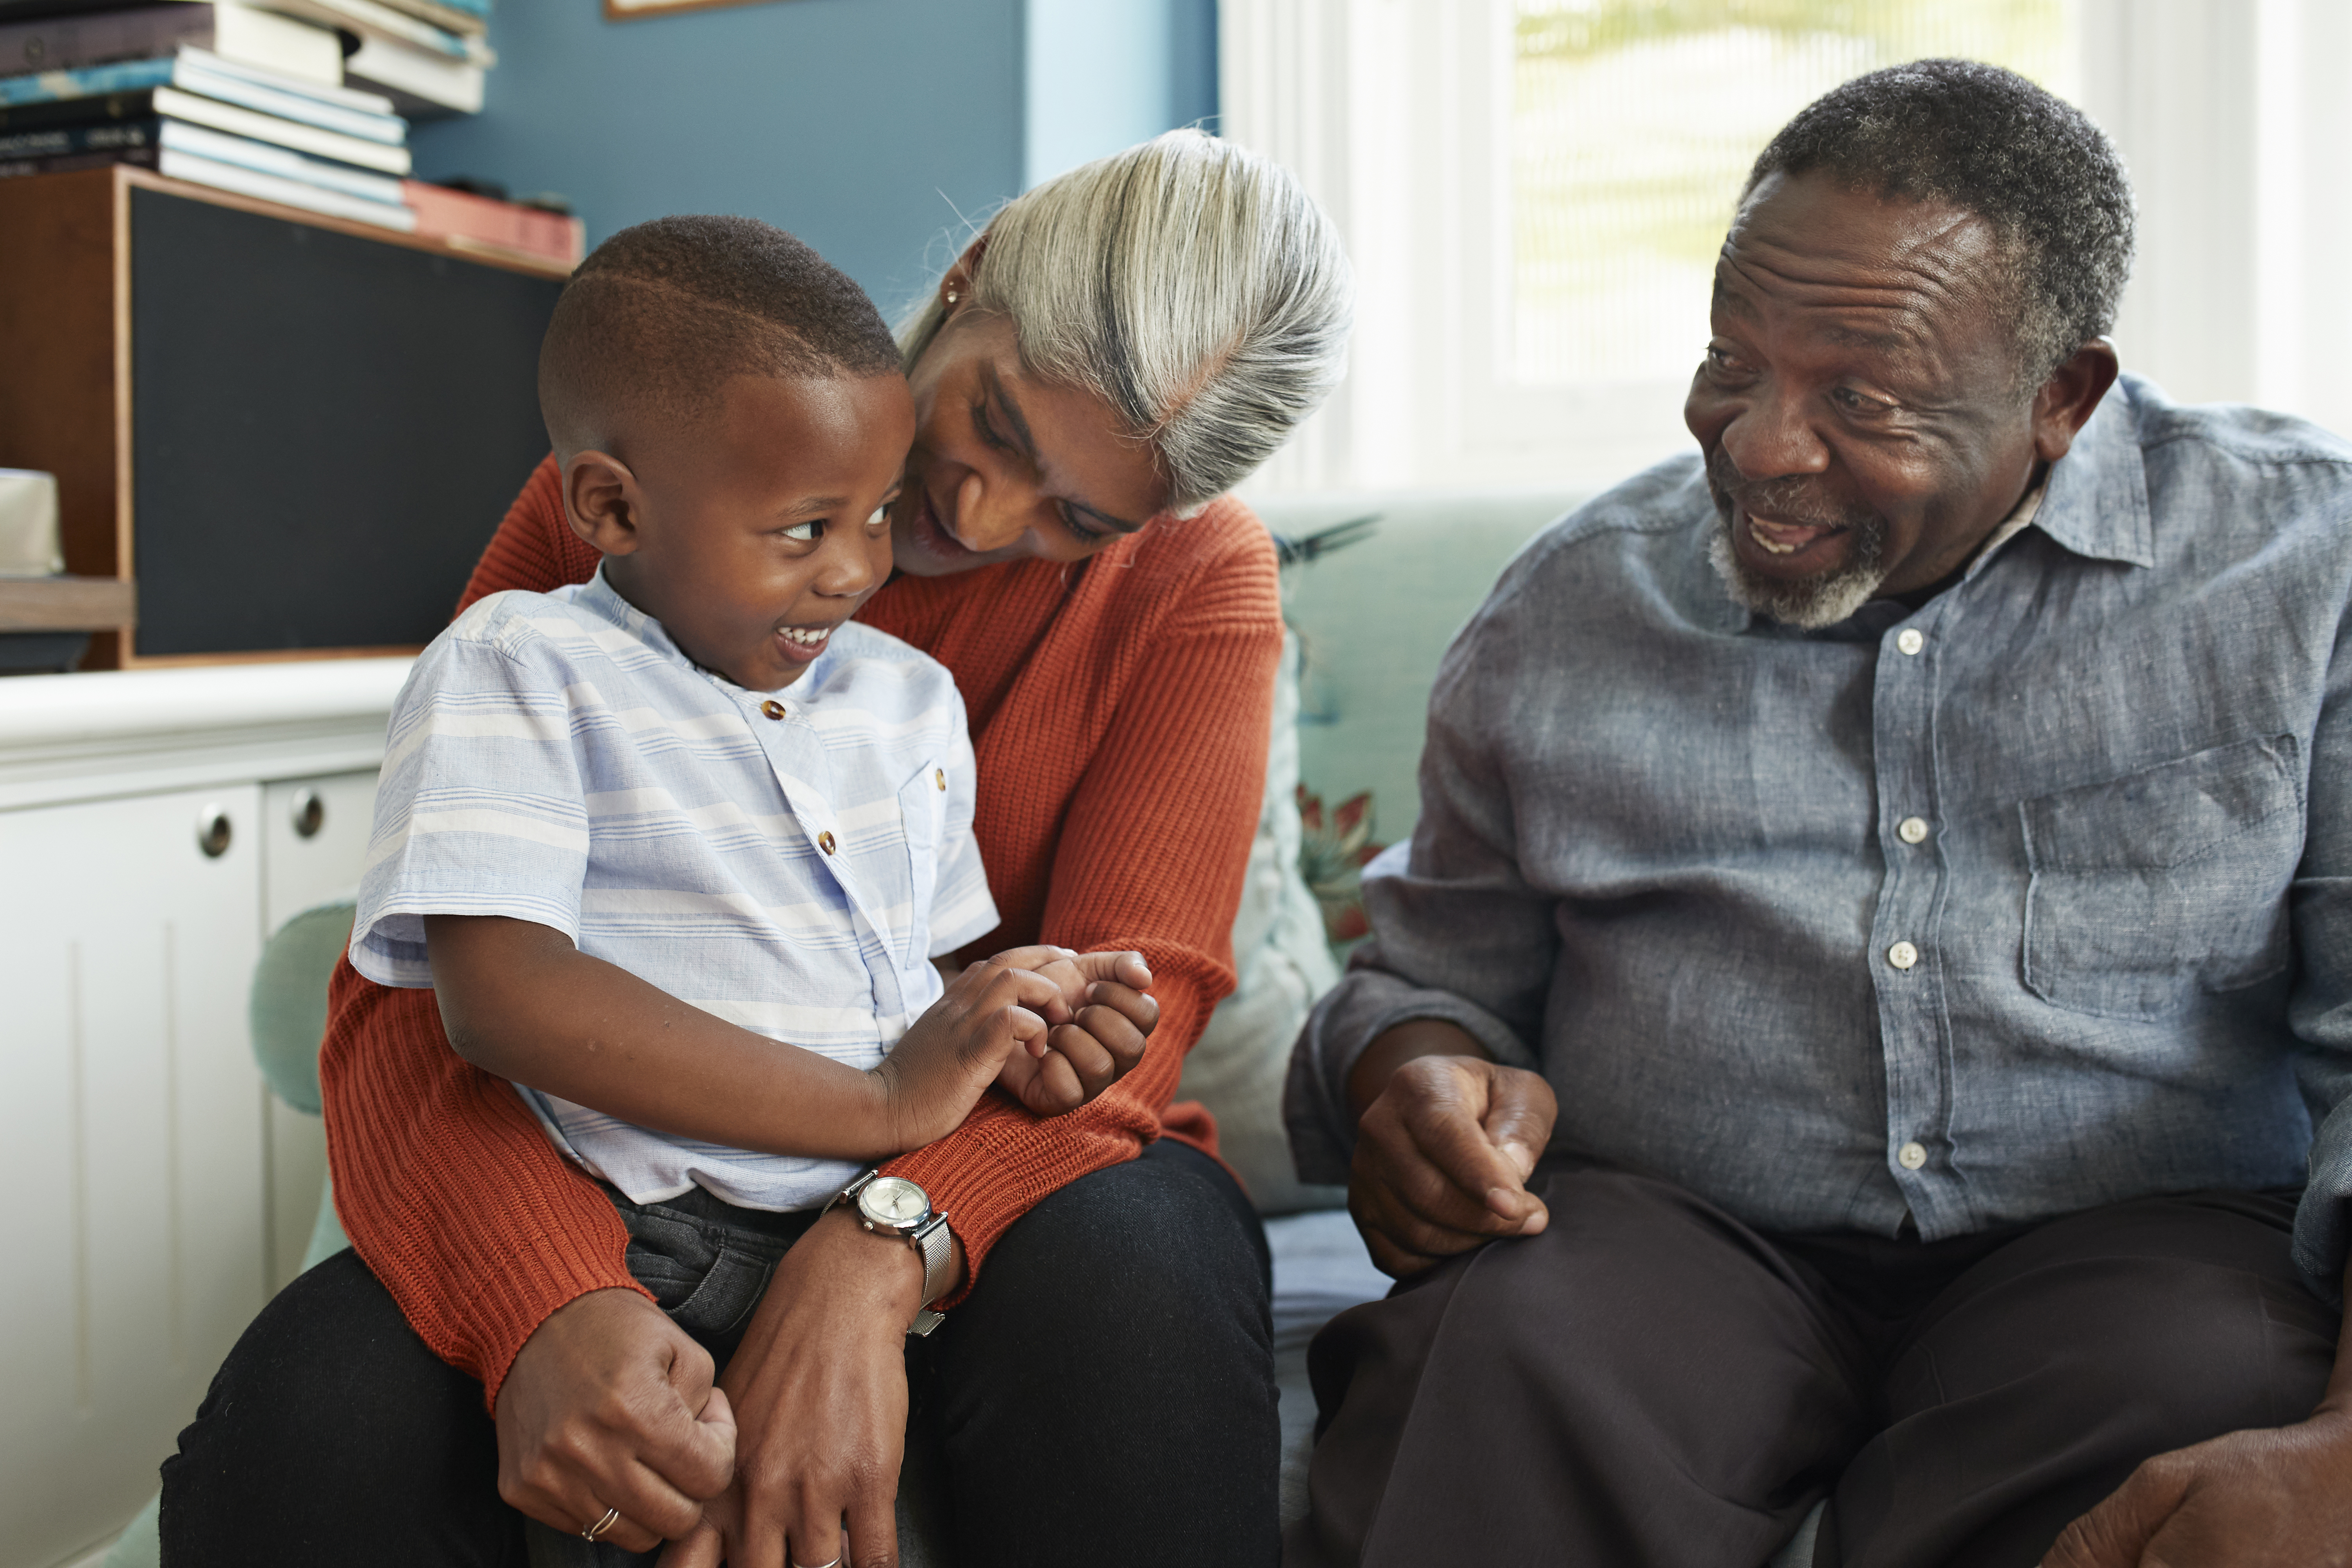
<box><xmin>661</xmin><ymin>1208</ymin><xmax>962</xmax><ymax>1568</ymax></box>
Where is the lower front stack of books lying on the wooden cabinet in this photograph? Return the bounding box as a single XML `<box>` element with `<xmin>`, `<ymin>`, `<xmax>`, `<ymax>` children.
<box><xmin>0</xmin><ymin>33</ymin><xmax>416</xmax><ymax>231</ymax></box>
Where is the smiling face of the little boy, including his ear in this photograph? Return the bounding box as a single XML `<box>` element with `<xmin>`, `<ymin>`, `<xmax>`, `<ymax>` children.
<box><xmin>565</xmin><ymin>376</ymin><xmax>915</xmax><ymax>691</ymax></box>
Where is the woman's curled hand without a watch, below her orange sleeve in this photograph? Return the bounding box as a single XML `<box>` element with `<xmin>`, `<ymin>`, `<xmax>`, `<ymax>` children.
<box><xmin>496</xmin><ymin>1291</ymin><xmax>738</xmax><ymax>1561</ymax></box>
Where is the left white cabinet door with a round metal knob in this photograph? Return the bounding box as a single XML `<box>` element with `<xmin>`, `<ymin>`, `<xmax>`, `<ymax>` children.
<box><xmin>0</xmin><ymin>785</ymin><xmax>263</xmax><ymax>1563</ymax></box>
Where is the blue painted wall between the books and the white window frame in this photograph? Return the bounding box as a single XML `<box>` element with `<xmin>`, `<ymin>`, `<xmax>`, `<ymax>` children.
<box><xmin>411</xmin><ymin>0</ymin><xmax>1216</xmax><ymax>315</ymax></box>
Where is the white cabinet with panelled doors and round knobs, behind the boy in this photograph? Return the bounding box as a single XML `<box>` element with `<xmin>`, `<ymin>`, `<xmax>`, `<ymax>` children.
<box><xmin>0</xmin><ymin>661</ymin><xmax>404</xmax><ymax>1568</ymax></box>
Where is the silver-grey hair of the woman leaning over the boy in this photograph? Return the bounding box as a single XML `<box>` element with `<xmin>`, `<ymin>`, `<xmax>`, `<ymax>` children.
<box><xmin>898</xmin><ymin>129</ymin><xmax>1355</xmax><ymax>513</ymax></box>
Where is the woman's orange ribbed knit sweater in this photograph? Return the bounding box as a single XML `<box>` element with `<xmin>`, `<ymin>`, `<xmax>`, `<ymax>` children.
<box><xmin>320</xmin><ymin>458</ymin><xmax>1282</xmax><ymax>1408</ymax></box>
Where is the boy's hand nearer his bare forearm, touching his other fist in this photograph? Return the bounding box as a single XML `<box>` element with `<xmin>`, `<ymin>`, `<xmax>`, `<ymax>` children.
<box><xmin>870</xmin><ymin>957</ymin><xmax>1070</xmax><ymax>1150</ymax></box>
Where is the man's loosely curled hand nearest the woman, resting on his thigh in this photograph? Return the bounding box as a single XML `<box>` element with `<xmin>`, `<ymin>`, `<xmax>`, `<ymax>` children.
<box><xmin>1348</xmin><ymin>1020</ymin><xmax>1560</xmax><ymax>1279</ymax></box>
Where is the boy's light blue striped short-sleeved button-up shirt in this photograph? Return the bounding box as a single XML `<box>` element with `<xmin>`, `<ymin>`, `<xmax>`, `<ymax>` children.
<box><xmin>351</xmin><ymin>571</ymin><xmax>997</xmax><ymax>1208</ymax></box>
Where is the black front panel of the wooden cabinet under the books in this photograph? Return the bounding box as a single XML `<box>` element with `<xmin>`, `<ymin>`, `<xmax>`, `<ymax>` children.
<box><xmin>129</xmin><ymin>188</ymin><xmax>562</xmax><ymax>656</ymax></box>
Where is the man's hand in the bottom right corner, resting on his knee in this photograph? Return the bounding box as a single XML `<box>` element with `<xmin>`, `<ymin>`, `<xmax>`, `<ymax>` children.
<box><xmin>2041</xmin><ymin>1408</ymin><xmax>2352</xmax><ymax>1568</ymax></box>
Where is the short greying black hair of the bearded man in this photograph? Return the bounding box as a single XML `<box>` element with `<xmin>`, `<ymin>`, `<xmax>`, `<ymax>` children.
<box><xmin>1740</xmin><ymin>59</ymin><xmax>2133</xmax><ymax>395</ymax></box>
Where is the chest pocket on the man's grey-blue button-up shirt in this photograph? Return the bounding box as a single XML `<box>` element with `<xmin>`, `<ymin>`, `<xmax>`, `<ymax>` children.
<box><xmin>2018</xmin><ymin>736</ymin><xmax>2303</xmax><ymax>1018</ymax></box>
